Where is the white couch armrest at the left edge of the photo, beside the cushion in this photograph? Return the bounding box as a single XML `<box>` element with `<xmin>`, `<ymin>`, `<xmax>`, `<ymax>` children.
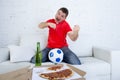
<box><xmin>0</xmin><ymin>48</ymin><xmax>9</xmax><ymax>63</ymax></box>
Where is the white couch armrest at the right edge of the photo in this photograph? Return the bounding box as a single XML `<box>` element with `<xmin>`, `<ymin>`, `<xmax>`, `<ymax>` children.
<box><xmin>93</xmin><ymin>47</ymin><xmax>120</xmax><ymax>80</ymax></box>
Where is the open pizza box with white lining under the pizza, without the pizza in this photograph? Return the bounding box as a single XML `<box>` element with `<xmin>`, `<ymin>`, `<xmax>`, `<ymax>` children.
<box><xmin>32</xmin><ymin>64</ymin><xmax>86</xmax><ymax>80</ymax></box>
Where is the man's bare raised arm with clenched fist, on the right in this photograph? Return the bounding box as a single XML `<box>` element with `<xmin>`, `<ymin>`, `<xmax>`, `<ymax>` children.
<box><xmin>67</xmin><ymin>25</ymin><xmax>80</xmax><ymax>41</ymax></box>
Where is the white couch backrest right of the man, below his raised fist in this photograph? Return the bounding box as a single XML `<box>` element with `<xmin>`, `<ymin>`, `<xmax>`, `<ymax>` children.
<box><xmin>67</xmin><ymin>36</ymin><xmax>92</xmax><ymax>57</ymax></box>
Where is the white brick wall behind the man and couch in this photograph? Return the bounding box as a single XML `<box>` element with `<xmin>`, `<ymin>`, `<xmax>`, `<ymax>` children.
<box><xmin>0</xmin><ymin>0</ymin><xmax>120</xmax><ymax>50</ymax></box>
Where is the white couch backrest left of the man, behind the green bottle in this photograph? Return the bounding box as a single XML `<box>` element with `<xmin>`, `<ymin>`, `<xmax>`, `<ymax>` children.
<box><xmin>20</xmin><ymin>34</ymin><xmax>47</xmax><ymax>50</ymax></box>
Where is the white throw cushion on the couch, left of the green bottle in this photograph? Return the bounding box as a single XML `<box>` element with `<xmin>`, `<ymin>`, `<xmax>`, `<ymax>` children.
<box><xmin>8</xmin><ymin>45</ymin><xmax>35</xmax><ymax>62</ymax></box>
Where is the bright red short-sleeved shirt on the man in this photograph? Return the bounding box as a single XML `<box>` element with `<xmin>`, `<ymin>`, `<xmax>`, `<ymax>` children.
<box><xmin>47</xmin><ymin>19</ymin><xmax>72</xmax><ymax>48</ymax></box>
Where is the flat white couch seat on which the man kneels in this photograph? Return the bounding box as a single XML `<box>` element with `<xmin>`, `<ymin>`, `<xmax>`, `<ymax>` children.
<box><xmin>0</xmin><ymin>57</ymin><xmax>110</xmax><ymax>78</ymax></box>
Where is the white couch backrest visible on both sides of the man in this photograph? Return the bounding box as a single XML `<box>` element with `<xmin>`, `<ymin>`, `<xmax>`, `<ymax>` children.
<box><xmin>20</xmin><ymin>34</ymin><xmax>92</xmax><ymax>57</ymax></box>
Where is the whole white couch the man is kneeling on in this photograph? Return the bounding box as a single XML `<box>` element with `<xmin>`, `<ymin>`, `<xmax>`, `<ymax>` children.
<box><xmin>0</xmin><ymin>34</ymin><xmax>120</xmax><ymax>80</ymax></box>
